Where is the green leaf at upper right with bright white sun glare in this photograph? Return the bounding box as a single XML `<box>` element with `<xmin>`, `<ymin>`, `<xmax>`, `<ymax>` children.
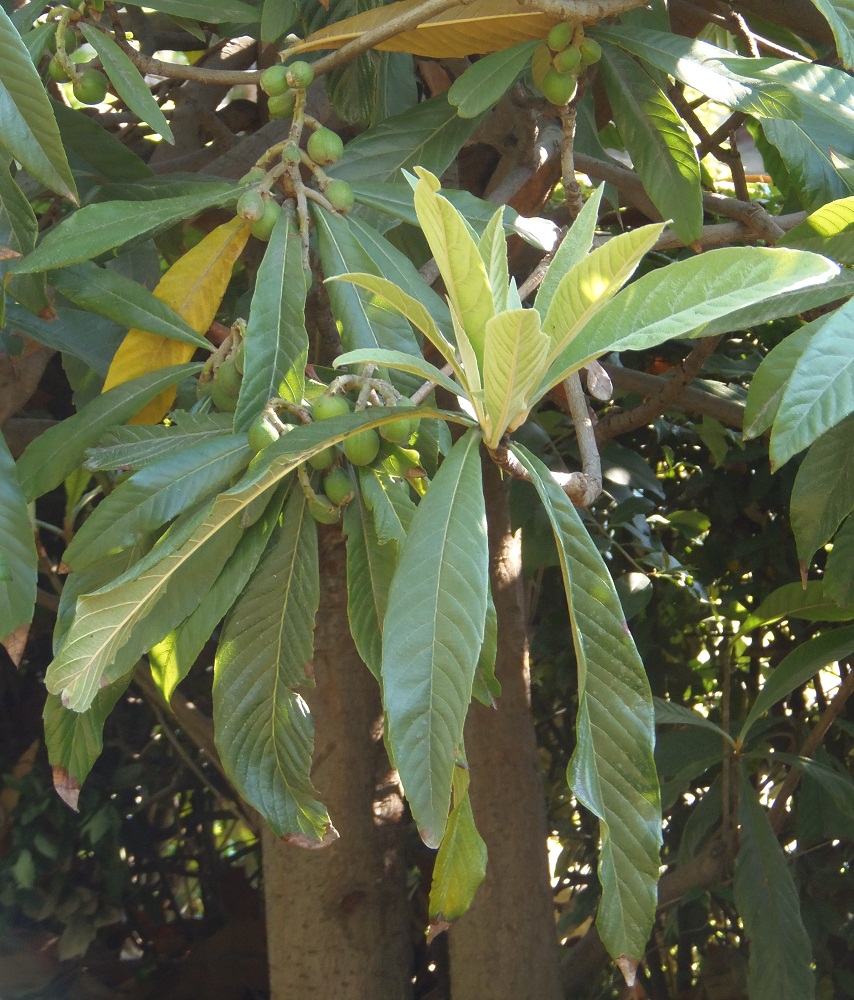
<box><xmin>590</xmin><ymin>25</ymin><xmax>800</xmax><ymax>118</ymax></box>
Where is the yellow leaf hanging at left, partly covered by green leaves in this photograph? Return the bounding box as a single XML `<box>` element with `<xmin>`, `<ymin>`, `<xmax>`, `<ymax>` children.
<box><xmin>103</xmin><ymin>218</ymin><xmax>249</xmax><ymax>424</ymax></box>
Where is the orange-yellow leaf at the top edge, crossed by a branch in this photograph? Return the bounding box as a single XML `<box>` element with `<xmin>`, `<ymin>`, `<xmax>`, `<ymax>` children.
<box><xmin>286</xmin><ymin>0</ymin><xmax>560</xmax><ymax>59</ymax></box>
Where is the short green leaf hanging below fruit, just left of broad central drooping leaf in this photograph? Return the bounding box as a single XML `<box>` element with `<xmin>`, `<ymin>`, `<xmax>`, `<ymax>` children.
<box><xmin>344</xmin><ymin>484</ymin><xmax>400</xmax><ymax>680</ymax></box>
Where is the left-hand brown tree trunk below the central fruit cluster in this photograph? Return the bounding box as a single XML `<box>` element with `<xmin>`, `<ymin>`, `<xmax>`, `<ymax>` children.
<box><xmin>263</xmin><ymin>528</ymin><xmax>412</xmax><ymax>1000</ymax></box>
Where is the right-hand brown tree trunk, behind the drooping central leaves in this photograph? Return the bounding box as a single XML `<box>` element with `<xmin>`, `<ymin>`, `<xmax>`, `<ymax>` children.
<box><xmin>449</xmin><ymin>462</ymin><xmax>562</xmax><ymax>1000</ymax></box>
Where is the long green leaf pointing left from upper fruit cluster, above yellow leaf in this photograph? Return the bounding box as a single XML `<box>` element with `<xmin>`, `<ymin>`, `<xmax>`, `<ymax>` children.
<box><xmin>10</xmin><ymin>181</ymin><xmax>242</xmax><ymax>274</ymax></box>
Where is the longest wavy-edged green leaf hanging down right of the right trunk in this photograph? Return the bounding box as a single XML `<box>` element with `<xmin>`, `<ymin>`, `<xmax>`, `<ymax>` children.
<box><xmin>512</xmin><ymin>445</ymin><xmax>661</xmax><ymax>960</ymax></box>
